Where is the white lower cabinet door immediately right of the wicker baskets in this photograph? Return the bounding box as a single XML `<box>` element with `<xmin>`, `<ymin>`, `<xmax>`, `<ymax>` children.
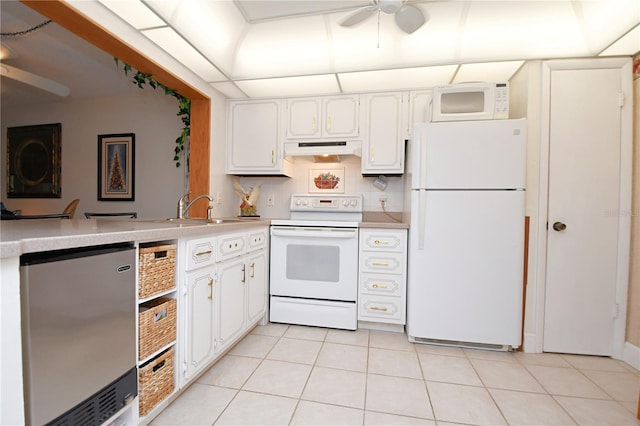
<box><xmin>185</xmin><ymin>268</ymin><xmax>214</xmax><ymax>379</ymax></box>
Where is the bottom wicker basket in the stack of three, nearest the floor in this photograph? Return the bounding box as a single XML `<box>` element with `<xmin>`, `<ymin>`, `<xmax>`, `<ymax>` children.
<box><xmin>138</xmin><ymin>347</ymin><xmax>174</xmax><ymax>416</ymax></box>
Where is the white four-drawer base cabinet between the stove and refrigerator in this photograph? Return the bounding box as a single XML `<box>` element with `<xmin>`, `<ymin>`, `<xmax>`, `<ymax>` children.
<box><xmin>358</xmin><ymin>228</ymin><xmax>407</xmax><ymax>325</ymax></box>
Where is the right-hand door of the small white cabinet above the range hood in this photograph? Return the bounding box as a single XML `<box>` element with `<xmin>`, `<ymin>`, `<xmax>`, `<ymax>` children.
<box><xmin>322</xmin><ymin>95</ymin><xmax>360</xmax><ymax>138</ymax></box>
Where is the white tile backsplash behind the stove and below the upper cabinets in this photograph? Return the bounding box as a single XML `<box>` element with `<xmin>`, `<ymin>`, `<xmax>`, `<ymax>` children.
<box><xmin>235</xmin><ymin>156</ymin><xmax>404</xmax><ymax>219</ymax></box>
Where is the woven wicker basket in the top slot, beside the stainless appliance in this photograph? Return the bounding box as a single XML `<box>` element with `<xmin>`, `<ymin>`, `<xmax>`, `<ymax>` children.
<box><xmin>138</xmin><ymin>244</ymin><xmax>176</xmax><ymax>299</ymax></box>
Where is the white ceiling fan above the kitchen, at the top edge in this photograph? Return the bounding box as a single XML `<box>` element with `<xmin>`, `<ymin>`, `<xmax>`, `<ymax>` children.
<box><xmin>338</xmin><ymin>0</ymin><xmax>427</xmax><ymax>34</ymax></box>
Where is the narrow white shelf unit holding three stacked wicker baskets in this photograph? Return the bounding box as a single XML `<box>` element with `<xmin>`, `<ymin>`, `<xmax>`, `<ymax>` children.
<box><xmin>138</xmin><ymin>241</ymin><xmax>177</xmax><ymax>417</ymax></box>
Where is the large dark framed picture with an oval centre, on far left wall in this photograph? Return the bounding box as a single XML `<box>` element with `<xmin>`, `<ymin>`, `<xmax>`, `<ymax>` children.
<box><xmin>7</xmin><ymin>123</ymin><xmax>62</xmax><ymax>198</ymax></box>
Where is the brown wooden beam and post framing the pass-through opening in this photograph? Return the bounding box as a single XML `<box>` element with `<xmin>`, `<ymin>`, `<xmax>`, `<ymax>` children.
<box><xmin>20</xmin><ymin>0</ymin><xmax>211</xmax><ymax>211</ymax></box>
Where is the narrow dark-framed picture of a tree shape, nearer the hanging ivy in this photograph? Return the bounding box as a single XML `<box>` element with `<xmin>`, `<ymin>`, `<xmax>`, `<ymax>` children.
<box><xmin>98</xmin><ymin>133</ymin><xmax>136</xmax><ymax>201</ymax></box>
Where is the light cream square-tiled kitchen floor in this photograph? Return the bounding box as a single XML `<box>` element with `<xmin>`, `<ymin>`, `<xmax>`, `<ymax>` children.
<box><xmin>151</xmin><ymin>324</ymin><xmax>640</xmax><ymax>426</ymax></box>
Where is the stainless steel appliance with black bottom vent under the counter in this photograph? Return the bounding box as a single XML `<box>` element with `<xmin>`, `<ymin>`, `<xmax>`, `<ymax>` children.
<box><xmin>20</xmin><ymin>243</ymin><xmax>137</xmax><ymax>425</ymax></box>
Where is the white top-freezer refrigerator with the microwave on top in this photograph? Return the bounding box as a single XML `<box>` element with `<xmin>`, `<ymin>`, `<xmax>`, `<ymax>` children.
<box><xmin>407</xmin><ymin>119</ymin><xmax>526</xmax><ymax>349</ymax></box>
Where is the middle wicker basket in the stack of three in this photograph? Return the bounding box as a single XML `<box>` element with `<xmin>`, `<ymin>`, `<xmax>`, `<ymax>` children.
<box><xmin>138</xmin><ymin>297</ymin><xmax>176</xmax><ymax>360</ymax></box>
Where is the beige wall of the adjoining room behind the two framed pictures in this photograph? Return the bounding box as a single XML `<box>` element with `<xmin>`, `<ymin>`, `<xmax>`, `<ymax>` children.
<box><xmin>0</xmin><ymin>89</ymin><xmax>184</xmax><ymax>218</ymax></box>
